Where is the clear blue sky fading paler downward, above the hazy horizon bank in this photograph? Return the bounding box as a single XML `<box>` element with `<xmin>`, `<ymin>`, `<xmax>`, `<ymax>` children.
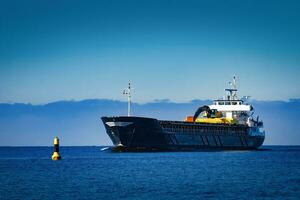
<box><xmin>0</xmin><ymin>0</ymin><xmax>300</xmax><ymax>103</ymax></box>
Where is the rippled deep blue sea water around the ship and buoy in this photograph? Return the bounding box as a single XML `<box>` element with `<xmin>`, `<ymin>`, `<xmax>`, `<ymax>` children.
<box><xmin>0</xmin><ymin>146</ymin><xmax>300</xmax><ymax>200</ymax></box>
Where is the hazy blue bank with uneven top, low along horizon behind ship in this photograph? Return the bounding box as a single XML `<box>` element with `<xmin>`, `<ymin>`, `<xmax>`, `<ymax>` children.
<box><xmin>0</xmin><ymin>99</ymin><xmax>300</xmax><ymax>146</ymax></box>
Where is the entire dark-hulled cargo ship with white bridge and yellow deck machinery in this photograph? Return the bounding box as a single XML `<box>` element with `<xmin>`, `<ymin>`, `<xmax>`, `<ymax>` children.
<box><xmin>101</xmin><ymin>77</ymin><xmax>265</xmax><ymax>151</ymax></box>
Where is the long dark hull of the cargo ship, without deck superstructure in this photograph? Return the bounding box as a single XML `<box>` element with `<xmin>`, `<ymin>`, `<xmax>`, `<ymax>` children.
<box><xmin>102</xmin><ymin>117</ymin><xmax>265</xmax><ymax>151</ymax></box>
